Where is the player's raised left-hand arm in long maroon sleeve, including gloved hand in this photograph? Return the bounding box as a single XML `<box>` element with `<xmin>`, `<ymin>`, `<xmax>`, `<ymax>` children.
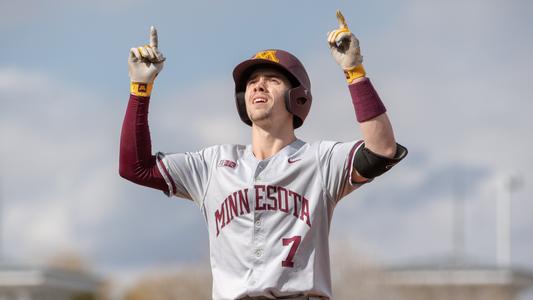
<box><xmin>119</xmin><ymin>26</ymin><xmax>168</xmax><ymax>191</ymax></box>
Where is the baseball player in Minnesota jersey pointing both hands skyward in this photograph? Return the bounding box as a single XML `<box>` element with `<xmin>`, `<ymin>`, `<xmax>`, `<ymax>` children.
<box><xmin>120</xmin><ymin>12</ymin><xmax>407</xmax><ymax>299</ymax></box>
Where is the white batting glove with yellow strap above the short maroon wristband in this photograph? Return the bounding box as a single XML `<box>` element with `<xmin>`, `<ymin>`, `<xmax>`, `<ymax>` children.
<box><xmin>328</xmin><ymin>10</ymin><xmax>366</xmax><ymax>83</ymax></box>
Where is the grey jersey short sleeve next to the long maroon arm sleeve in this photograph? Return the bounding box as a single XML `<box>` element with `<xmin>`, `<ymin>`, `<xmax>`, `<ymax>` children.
<box><xmin>157</xmin><ymin>147</ymin><xmax>218</xmax><ymax>206</ymax></box>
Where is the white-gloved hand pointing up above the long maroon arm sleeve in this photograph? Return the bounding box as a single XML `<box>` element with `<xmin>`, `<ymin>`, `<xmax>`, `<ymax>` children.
<box><xmin>128</xmin><ymin>26</ymin><xmax>166</xmax><ymax>84</ymax></box>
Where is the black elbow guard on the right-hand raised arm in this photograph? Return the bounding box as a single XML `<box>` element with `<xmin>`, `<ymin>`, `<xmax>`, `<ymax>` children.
<box><xmin>354</xmin><ymin>143</ymin><xmax>407</xmax><ymax>179</ymax></box>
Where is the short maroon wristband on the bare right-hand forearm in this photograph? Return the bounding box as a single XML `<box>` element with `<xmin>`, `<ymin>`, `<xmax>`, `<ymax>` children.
<box><xmin>348</xmin><ymin>78</ymin><xmax>387</xmax><ymax>123</ymax></box>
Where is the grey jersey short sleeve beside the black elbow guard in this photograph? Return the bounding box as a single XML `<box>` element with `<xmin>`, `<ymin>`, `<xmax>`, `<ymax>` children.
<box><xmin>318</xmin><ymin>140</ymin><xmax>369</xmax><ymax>203</ymax></box>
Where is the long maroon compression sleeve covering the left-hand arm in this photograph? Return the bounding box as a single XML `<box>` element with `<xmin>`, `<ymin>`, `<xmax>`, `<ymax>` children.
<box><xmin>119</xmin><ymin>95</ymin><xmax>168</xmax><ymax>192</ymax></box>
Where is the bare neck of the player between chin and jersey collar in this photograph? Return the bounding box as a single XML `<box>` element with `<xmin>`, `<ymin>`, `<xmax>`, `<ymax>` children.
<box><xmin>252</xmin><ymin>124</ymin><xmax>296</xmax><ymax>160</ymax></box>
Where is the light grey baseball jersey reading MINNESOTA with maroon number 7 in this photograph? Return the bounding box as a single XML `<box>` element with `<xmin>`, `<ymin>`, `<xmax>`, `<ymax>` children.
<box><xmin>158</xmin><ymin>140</ymin><xmax>362</xmax><ymax>299</ymax></box>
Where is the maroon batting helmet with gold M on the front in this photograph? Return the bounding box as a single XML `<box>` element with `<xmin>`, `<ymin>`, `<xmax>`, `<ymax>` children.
<box><xmin>233</xmin><ymin>49</ymin><xmax>312</xmax><ymax>129</ymax></box>
